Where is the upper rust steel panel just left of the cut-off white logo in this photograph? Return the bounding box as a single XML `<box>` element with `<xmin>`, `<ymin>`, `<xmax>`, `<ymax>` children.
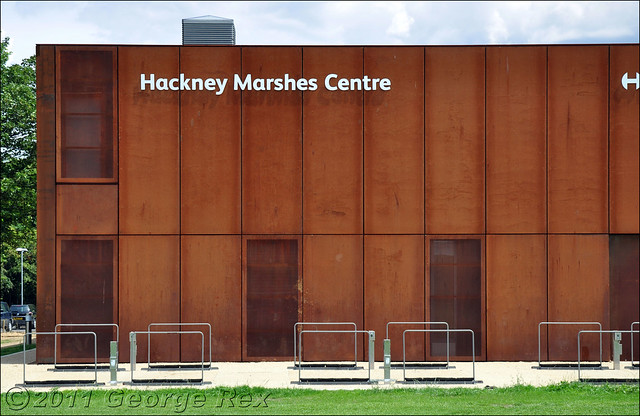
<box><xmin>547</xmin><ymin>46</ymin><xmax>608</xmax><ymax>233</ymax></box>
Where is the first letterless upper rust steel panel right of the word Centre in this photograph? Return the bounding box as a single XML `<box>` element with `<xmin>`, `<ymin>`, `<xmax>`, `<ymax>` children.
<box><xmin>424</xmin><ymin>47</ymin><xmax>485</xmax><ymax>234</ymax></box>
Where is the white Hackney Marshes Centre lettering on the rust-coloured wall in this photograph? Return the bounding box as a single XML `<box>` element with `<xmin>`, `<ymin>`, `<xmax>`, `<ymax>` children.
<box><xmin>140</xmin><ymin>74</ymin><xmax>391</xmax><ymax>95</ymax></box>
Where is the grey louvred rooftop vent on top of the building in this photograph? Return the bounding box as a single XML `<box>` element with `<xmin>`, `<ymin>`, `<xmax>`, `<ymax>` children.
<box><xmin>182</xmin><ymin>16</ymin><xmax>236</xmax><ymax>45</ymax></box>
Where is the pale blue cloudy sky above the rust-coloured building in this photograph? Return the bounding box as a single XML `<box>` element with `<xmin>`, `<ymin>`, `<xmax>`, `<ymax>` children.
<box><xmin>1</xmin><ymin>0</ymin><xmax>640</xmax><ymax>63</ymax></box>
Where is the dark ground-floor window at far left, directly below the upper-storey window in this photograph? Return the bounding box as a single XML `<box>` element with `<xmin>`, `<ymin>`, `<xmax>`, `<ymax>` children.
<box><xmin>58</xmin><ymin>239</ymin><xmax>116</xmax><ymax>361</ymax></box>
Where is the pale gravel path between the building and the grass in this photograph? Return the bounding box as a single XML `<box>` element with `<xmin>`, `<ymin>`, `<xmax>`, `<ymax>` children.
<box><xmin>1</xmin><ymin>356</ymin><xmax>639</xmax><ymax>392</ymax></box>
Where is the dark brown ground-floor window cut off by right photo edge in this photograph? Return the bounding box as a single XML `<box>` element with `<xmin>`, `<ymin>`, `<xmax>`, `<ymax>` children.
<box><xmin>609</xmin><ymin>234</ymin><xmax>640</xmax><ymax>362</ymax></box>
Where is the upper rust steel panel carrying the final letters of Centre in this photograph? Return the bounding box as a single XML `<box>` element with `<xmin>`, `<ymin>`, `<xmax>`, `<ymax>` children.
<box><xmin>364</xmin><ymin>47</ymin><xmax>424</xmax><ymax>234</ymax></box>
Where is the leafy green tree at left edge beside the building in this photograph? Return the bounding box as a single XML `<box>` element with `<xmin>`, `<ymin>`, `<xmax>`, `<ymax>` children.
<box><xmin>0</xmin><ymin>38</ymin><xmax>36</xmax><ymax>304</ymax></box>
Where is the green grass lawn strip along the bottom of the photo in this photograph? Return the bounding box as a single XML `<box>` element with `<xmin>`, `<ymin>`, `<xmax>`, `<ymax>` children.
<box><xmin>2</xmin><ymin>382</ymin><xmax>639</xmax><ymax>415</ymax></box>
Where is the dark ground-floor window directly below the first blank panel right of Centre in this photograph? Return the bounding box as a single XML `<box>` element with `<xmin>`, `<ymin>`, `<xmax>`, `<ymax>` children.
<box><xmin>429</xmin><ymin>239</ymin><xmax>482</xmax><ymax>357</ymax></box>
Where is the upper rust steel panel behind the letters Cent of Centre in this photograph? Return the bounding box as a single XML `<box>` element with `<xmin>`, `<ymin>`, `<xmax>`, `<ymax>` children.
<box><xmin>302</xmin><ymin>48</ymin><xmax>363</xmax><ymax>234</ymax></box>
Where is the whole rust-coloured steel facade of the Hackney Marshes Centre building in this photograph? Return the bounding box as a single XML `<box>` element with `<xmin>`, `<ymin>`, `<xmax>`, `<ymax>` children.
<box><xmin>37</xmin><ymin>44</ymin><xmax>640</xmax><ymax>362</ymax></box>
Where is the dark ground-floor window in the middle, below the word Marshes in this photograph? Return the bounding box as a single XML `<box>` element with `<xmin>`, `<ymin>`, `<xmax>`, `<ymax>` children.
<box><xmin>246</xmin><ymin>240</ymin><xmax>298</xmax><ymax>357</ymax></box>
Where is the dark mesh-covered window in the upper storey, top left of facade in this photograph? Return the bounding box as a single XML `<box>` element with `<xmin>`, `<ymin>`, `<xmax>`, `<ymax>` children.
<box><xmin>58</xmin><ymin>49</ymin><xmax>115</xmax><ymax>182</ymax></box>
